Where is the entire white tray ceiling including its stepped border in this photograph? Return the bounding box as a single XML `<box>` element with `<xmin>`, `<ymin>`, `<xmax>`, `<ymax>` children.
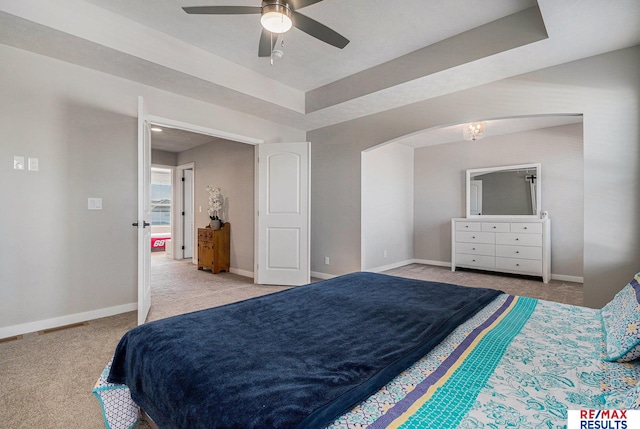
<box><xmin>0</xmin><ymin>0</ymin><xmax>640</xmax><ymax>146</ymax></box>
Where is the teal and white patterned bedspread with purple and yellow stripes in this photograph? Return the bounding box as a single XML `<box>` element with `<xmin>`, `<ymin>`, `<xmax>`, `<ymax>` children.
<box><xmin>94</xmin><ymin>295</ymin><xmax>640</xmax><ymax>429</ymax></box>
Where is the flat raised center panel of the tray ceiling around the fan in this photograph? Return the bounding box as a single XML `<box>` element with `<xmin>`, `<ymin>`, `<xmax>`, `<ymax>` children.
<box><xmin>80</xmin><ymin>0</ymin><xmax>536</xmax><ymax>91</ymax></box>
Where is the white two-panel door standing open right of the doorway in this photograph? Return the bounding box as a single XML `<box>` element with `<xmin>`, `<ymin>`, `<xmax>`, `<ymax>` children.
<box><xmin>255</xmin><ymin>143</ymin><xmax>310</xmax><ymax>285</ymax></box>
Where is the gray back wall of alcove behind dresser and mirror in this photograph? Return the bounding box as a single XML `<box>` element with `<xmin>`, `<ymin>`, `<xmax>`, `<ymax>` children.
<box><xmin>415</xmin><ymin>124</ymin><xmax>584</xmax><ymax>277</ymax></box>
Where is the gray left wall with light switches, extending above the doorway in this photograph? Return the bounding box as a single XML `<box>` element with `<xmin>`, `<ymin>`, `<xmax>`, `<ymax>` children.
<box><xmin>0</xmin><ymin>45</ymin><xmax>305</xmax><ymax>338</ymax></box>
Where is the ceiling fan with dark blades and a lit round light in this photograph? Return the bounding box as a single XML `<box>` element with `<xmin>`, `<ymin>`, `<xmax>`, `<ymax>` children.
<box><xmin>182</xmin><ymin>0</ymin><xmax>349</xmax><ymax>57</ymax></box>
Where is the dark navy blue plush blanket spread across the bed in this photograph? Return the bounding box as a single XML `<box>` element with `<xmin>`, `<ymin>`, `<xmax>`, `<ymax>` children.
<box><xmin>108</xmin><ymin>273</ymin><xmax>500</xmax><ymax>429</ymax></box>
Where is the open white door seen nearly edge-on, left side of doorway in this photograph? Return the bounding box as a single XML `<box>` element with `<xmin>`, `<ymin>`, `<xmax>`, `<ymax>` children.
<box><xmin>134</xmin><ymin>97</ymin><xmax>151</xmax><ymax>325</ymax></box>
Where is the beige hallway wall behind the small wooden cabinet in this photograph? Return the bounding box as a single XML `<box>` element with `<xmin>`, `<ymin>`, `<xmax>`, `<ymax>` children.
<box><xmin>178</xmin><ymin>140</ymin><xmax>255</xmax><ymax>273</ymax></box>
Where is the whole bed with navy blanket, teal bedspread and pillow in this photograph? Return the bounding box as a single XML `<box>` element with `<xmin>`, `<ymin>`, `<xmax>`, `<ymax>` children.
<box><xmin>94</xmin><ymin>273</ymin><xmax>640</xmax><ymax>429</ymax></box>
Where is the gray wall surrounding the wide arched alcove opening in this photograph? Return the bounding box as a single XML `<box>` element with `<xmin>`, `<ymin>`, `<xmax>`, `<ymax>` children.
<box><xmin>307</xmin><ymin>46</ymin><xmax>640</xmax><ymax>307</ymax></box>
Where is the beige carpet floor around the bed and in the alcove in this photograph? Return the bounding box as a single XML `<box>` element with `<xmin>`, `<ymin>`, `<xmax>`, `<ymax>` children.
<box><xmin>0</xmin><ymin>253</ymin><xmax>582</xmax><ymax>429</ymax></box>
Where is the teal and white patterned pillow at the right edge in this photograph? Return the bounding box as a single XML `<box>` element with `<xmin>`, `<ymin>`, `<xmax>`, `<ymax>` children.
<box><xmin>600</xmin><ymin>273</ymin><xmax>640</xmax><ymax>362</ymax></box>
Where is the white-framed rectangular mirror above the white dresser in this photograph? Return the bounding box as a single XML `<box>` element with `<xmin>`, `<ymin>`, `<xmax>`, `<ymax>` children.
<box><xmin>466</xmin><ymin>164</ymin><xmax>542</xmax><ymax>218</ymax></box>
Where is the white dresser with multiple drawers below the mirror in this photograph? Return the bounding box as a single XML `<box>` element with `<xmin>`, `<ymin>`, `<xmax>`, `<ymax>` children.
<box><xmin>451</xmin><ymin>217</ymin><xmax>551</xmax><ymax>283</ymax></box>
